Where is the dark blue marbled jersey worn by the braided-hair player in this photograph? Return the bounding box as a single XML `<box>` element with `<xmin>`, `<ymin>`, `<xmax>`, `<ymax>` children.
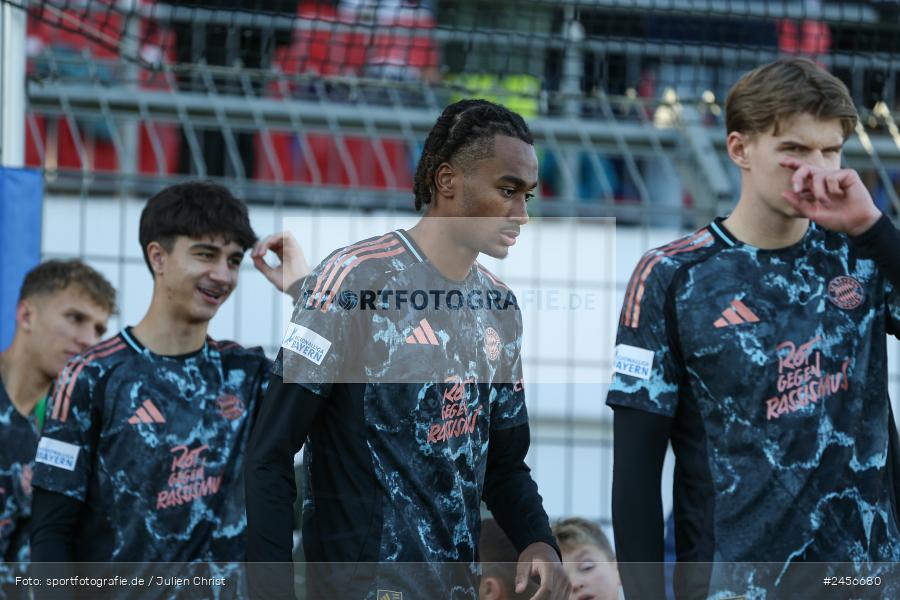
<box><xmin>275</xmin><ymin>230</ymin><xmax>527</xmax><ymax>597</ymax></box>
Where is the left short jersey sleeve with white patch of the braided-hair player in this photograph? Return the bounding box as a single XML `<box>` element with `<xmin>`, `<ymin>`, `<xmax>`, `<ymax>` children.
<box><xmin>272</xmin><ymin>256</ymin><xmax>359</xmax><ymax>396</ymax></box>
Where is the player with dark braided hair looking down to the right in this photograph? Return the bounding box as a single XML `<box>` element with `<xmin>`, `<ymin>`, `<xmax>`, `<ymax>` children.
<box><xmin>246</xmin><ymin>100</ymin><xmax>568</xmax><ymax>599</ymax></box>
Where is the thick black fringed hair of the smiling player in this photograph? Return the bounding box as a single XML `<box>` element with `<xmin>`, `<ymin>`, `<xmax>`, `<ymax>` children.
<box><xmin>139</xmin><ymin>181</ymin><xmax>257</xmax><ymax>274</ymax></box>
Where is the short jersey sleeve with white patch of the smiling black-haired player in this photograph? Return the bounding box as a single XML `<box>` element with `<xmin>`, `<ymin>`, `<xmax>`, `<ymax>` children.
<box><xmin>32</xmin><ymin>357</ymin><xmax>102</xmax><ymax>502</ymax></box>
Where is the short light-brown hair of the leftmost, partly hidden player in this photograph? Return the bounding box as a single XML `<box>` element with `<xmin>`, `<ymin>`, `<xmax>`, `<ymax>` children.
<box><xmin>19</xmin><ymin>258</ymin><xmax>116</xmax><ymax>314</ymax></box>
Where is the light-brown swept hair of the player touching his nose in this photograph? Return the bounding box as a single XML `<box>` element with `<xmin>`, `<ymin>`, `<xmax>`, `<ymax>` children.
<box><xmin>725</xmin><ymin>57</ymin><xmax>858</xmax><ymax>140</ymax></box>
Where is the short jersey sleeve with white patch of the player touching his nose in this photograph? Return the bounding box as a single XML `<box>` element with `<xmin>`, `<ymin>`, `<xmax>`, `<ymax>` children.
<box><xmin>606</xmin><ymin>251</ymin><xmax>683</xmax><ymax>417</ymax></box>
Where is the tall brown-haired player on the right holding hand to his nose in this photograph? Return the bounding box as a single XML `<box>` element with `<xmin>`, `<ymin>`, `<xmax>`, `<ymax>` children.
<box><xmin>607</xmin><ymin>59</ymin><xmax>900</xmax><ymax>598</ymax></box>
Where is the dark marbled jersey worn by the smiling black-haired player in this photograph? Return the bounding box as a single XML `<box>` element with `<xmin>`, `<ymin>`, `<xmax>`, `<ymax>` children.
<box><xmin>33</xmin><ymin>329</ymin><xmax>271</xmax><ymax>562</ymax></box>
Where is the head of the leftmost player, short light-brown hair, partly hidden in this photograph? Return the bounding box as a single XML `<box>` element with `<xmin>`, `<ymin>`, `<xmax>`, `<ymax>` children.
<box><xmin>13</xmin><ymin>260</ymin><xmax>116</xmax><ymax>379</ymax></box>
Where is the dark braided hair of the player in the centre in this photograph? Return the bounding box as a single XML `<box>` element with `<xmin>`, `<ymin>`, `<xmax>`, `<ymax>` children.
<box><xmin>413</xmin><ymin>99</ymin><xmax>534</xmax><ymax>210</ymax></box>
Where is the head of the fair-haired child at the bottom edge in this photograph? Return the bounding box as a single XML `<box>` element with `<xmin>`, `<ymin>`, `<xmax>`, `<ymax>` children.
<box><xmin>553</xmin><ymin>518</ymin><xmax>619</xmax><ymax>600</ymax></box>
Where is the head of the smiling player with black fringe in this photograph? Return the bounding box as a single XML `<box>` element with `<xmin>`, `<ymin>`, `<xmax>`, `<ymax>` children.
<box><xmin>140</xmin><ymin>181</ymin><xmax>257</xmax><ymax>322</ymax></box>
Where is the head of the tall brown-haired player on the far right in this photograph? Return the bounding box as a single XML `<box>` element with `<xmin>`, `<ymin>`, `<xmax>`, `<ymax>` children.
<box><xmin>725</xmin><ymin>58</ymin><xmax>858</xmax><ymax>217</ymax></box>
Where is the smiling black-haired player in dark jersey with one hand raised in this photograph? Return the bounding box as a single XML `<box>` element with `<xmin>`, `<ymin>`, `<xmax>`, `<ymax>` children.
<box><xmin>32</xmin><ymin>182</ymin><xmax>308</xmax><ymax>584</ymax></box>
